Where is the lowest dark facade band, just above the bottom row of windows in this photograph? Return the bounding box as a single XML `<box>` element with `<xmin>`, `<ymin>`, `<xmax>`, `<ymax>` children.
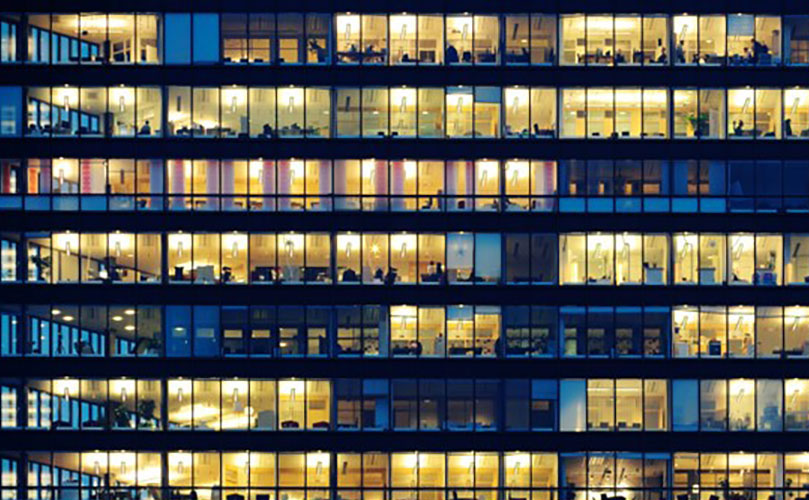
<box><xmin>3</xmin><ymin>431</ymin><xmax>806</xmax><ymax>452</ymax></box>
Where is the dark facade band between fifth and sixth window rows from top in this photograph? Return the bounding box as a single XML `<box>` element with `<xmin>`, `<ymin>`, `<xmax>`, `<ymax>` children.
<box><xmin>0</xmin><ymin>358</ymin><xmax>806</xmax><ymax>379</ymax></box>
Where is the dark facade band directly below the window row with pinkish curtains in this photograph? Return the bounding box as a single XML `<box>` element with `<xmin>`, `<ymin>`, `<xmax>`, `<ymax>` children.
<box><xmin>3</xmin><ymin>211</ymin><xmax>807</xmax><ymax>233</ymax></box>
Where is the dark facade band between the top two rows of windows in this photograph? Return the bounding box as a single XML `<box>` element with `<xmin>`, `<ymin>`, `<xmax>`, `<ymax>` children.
<box><xmin>0</xmin><ymin>65</ymin><xmax>809</xmax><ymax>87</ymax></box>
